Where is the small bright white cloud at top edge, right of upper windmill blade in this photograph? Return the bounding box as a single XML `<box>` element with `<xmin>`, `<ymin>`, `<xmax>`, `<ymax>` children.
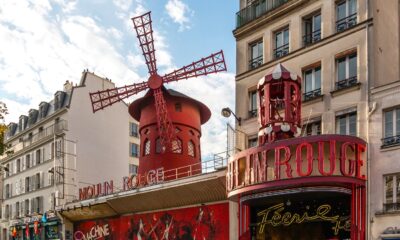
<box><xmin>165</xmin><ymin>0</ymin><xmax>193</xmax><ymax>31</ymax></box>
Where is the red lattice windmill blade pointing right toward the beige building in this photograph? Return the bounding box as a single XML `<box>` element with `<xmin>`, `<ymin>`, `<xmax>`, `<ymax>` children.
<box><xmin>163</xmin><ymin>50</ymin><xmax>226</xmax><ymax>83</ymax></box>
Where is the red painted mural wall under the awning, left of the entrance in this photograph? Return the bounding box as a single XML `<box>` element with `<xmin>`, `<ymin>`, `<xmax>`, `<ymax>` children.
<box><xmin>74</xmin><ymin>203</ymin><xmax>229</xmax><ymax>240</ymax></box>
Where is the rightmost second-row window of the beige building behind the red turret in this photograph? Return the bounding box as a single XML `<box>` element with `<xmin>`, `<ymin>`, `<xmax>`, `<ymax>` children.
<box><xmin>336</xmin><ymin>53</ymin><xmax>357</xmax><ymax>90</ymax></box>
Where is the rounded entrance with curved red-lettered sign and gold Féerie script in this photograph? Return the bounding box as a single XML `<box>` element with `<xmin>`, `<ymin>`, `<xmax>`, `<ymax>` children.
<box><xmin>227</xmin><ymin>135</ymin><xmax>366</xmax><ymax>240</ymax></box>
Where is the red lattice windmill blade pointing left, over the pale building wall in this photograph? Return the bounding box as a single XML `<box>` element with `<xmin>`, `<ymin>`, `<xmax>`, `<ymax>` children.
<box><xmin>90</xmin><ymin>82</ymin><xmax>148</xmax><ymax>112</ymax></box>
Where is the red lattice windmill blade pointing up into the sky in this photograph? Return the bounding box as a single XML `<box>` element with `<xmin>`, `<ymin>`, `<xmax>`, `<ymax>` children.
<box><xmin>132</xmin><ymin>12</ymin><xmax>157</xmax><ymax>75</ymax></box>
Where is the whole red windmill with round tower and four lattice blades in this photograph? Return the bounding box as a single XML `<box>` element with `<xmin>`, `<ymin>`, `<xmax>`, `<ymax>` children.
<box><xmin>90</xmin><ymin>12</ymin><xmax>226</xmax><ymax>174</ymax></box>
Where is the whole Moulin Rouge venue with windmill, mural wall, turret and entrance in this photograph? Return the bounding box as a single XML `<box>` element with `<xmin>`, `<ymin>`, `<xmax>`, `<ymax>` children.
<box><xmin>38</xmin><ymin>13</ymin><xmax>367</xmax><ymax>240</ymax></box>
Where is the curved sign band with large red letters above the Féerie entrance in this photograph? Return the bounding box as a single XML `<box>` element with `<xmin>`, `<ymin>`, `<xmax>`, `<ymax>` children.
<box><xmin>226</xmin><ymin>135</ymin><xmax>366</xmax><ymax>196</ymax></box>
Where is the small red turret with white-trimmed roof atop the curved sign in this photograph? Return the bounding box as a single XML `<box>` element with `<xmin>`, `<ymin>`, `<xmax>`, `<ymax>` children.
<box><xmin>257</xmin><ymin>63</ymin><xmax>301</xmax><ymax>145</ymax></box>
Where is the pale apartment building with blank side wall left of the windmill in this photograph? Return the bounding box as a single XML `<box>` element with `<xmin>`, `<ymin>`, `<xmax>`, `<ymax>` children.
<box><xmin>0</xmin><ymin>71</ymin><xmax>138</xmax><ymax>239</ymax></box>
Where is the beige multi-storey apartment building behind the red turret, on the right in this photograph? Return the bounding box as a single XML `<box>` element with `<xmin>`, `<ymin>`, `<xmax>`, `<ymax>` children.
<box><xmin>233</xmin><ymin>0</ymin><xmax>400</xmax><ymax>239</ymax></box>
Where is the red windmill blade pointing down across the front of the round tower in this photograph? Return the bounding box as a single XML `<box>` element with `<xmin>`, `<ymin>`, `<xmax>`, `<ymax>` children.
<box><xmin>153</xmin><ymin>88</ymin><xmax>182</xmax><ymax>152</ymax></box>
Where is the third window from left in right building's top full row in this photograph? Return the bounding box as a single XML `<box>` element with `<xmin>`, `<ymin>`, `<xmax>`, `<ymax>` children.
<box><xmin>303</xmin><ymin>12</ymin><xmax>321</xmax><ymax>46</ymax></box>
